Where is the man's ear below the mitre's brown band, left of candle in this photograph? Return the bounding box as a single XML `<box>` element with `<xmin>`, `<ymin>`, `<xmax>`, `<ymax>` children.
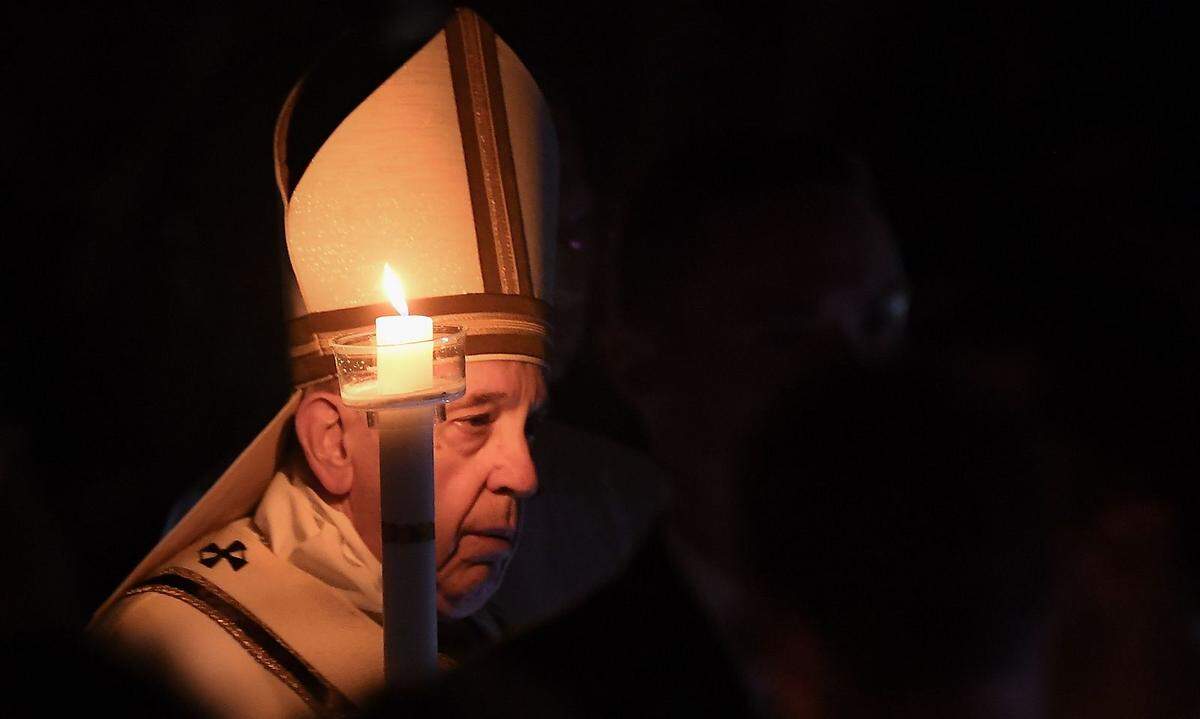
<box><xmin>295</xmin><ymin>389</ymin><xmax>354</xmax><ymax>496</ymax></box>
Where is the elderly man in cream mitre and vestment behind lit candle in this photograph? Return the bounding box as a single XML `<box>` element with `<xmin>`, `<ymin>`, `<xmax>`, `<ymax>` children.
<box><xmin>92</xmin><ymin>11</ymin><xmax>557</xmax><ymax>717</ymax></box>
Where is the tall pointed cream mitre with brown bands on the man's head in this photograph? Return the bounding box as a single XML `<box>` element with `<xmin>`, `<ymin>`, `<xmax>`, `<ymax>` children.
<box><xmin>275</xmin><ymin>10</ymin><xmax>558</xmax><ymax>386</ymax></box>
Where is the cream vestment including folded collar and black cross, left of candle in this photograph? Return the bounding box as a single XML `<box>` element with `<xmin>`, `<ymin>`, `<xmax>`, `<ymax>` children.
<box><xmin>92</xmin><ymin>473</ymin><xmax>384</xmax><ymax>717</ymax></box>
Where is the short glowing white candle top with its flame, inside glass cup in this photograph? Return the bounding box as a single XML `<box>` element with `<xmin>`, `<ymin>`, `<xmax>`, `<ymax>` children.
<box><xmin>374</xmin><ymin>264</ymin><xmax>433</xmax><ymax>396</ymax></box>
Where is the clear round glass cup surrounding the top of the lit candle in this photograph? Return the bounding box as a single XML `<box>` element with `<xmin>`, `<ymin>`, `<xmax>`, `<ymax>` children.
<box><xmin>329</xmin><ymin>324</ymin><xmax>467</xmax><ymax>411</ymax></box>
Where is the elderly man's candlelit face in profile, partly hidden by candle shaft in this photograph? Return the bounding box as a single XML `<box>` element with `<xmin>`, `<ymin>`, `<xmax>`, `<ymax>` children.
<box><xmin>350</xmin><ymin>360</ymin><xmax>546</xmax><ymax>617</ymax></box>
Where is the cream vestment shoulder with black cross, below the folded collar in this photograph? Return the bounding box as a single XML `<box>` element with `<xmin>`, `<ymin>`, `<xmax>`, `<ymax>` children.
<box><xmin>95</xmin><ymin>519</ymin><xmax>383</xmax><ymax>717</ymax></box>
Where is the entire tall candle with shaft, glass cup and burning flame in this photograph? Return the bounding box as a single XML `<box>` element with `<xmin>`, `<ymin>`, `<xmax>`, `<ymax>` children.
<box><xmin>330</xmin><ymin>264</ymin><xmax>467</xmax><ymax>684</ymax></box>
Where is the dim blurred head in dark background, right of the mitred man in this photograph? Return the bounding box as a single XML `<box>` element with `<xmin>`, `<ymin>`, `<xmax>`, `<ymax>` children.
<box><xmin>605</xmin><ymin>132</ymin><xmax>908</xmax><ymax>571</ymax></box>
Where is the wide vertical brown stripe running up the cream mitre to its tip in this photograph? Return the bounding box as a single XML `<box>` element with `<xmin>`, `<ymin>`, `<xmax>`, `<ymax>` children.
<box><xmin>446</xmin><ymin>8</ymin><xmax>534</xmax><ymax>296</ymax></box>
